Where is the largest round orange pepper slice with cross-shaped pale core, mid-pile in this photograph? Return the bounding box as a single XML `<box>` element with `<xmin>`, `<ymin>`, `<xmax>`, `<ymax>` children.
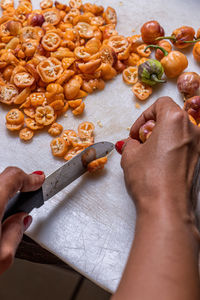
<box><xmin>37</xmin><ymin>57</ymin><xmax>63</xmax><ymax>82</ymax></box>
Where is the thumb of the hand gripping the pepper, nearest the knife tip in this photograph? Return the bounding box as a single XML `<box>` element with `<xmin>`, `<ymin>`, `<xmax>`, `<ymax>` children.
<box><xmin>121</xmin><ymin>138</ymin><xmax>142</xmax><ymax>170</ymax></box>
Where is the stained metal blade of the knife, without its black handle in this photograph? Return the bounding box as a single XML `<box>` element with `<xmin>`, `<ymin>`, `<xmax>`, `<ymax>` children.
<box><xmin>42</xmin><ymin>142</ymin><xmax>114</xmax><ymax>201</ymax></box>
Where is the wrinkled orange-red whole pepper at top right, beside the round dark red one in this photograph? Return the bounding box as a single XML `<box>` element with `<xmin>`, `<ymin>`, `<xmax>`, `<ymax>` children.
<box><xmin>156</xmin><ymin>26</ymin><xmax>196</xmax><ymax>49</ymax></box>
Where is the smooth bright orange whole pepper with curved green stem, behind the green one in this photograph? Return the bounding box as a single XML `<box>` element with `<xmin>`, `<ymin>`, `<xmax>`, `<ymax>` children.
<box><xmin>146</xmin><ymin>45</ymin><xmax>188</xmax><ymax>78</ymax></box>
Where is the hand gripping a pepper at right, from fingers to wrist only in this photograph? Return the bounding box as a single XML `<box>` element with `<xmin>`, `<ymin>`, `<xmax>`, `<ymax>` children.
<box><xmin>117</xmin><ymin>97</ymin><xmax>200</xmax><ymax>218</ymax></box>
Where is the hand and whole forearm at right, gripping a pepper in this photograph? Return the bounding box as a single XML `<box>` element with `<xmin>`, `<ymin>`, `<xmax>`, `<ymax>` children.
<box><xmin>112</xmin><ymin>97</ymin><xmax>200</xmax><ymax>300</ymax></box>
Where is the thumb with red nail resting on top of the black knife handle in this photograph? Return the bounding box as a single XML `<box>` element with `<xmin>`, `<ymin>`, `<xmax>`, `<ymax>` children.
<box><xmin>0</xmin><ymin>167</ymin><xmax>45</xmax><ymax>215</ymax></box>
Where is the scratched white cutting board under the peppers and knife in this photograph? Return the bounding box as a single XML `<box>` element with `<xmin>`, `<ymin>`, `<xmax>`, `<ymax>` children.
<box><xmin>0</xmin><ymin>0</ymin><xmax>200</xmax><ymax>292</ymax></box>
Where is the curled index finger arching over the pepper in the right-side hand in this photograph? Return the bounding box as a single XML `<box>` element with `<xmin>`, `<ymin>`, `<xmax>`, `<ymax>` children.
<box><xmin>130</xmin><ymin>97</ymin><xmax>180</xmax><ymax>140</ymax></box>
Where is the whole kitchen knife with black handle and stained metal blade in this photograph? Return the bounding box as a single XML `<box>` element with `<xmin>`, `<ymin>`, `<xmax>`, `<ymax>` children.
<box><xmin>3</xmin><ymin>142</ymin><xmax>114</xmax><ymax>221</ymax></box>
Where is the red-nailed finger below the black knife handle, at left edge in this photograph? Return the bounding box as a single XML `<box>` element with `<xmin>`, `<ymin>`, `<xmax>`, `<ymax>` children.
<box><xmin>0</xmin><ymin>213</ymin><xmax>32</xmax><ymax>274</ymax></box>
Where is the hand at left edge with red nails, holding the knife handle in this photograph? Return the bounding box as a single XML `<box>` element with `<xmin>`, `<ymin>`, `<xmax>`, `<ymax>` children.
<box><xmin>0</xmin><ymin>167</ymin><xmax>45</xmax><ymax>275</ymax></box>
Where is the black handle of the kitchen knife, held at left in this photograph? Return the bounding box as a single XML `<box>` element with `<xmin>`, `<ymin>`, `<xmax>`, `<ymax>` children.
<box><xmin>3</xmin><ymin>187</ymin><xmax>44</xmax><ymax>221</ymax></box>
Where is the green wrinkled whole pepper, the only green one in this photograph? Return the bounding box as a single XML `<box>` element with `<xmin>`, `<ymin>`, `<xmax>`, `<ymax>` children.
<box><xmin>138</xmin><ymin>59</ymin><xmax>165</xmax><ymax>86</ymax></box>
